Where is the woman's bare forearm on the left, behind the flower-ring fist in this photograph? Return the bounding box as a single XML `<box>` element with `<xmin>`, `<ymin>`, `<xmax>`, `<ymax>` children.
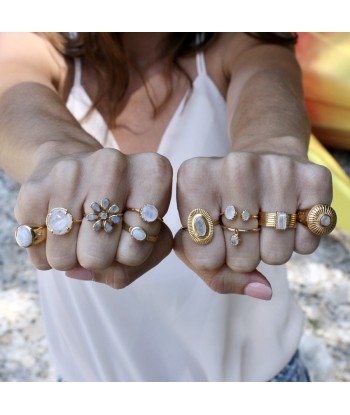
<box><xmin>0</xmin><ymin>82</ymin><xmax>101</xmax><ymax>182</ymax></box>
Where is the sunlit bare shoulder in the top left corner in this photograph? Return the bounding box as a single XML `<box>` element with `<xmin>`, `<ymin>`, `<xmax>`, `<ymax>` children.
<box><xmin>0</xmin><ymin>33</ymin><xmax>67</xmax><ymax>94</ymax></box>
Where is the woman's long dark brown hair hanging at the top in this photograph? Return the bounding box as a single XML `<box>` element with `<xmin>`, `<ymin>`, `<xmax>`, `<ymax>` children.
<box><xmin>41</xmin><ymin>32</ymin><xmax>296</xmax><ymax>126</ymax></box>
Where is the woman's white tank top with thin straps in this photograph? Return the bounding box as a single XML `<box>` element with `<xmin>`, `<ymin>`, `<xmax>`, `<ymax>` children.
<box><xmin>39</xmin><ymin>54</ymin><xmax>303</xmax><ymax>381</ymax></box>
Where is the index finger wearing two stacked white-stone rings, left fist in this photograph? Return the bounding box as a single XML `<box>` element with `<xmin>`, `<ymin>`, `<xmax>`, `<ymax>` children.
<box><xmin>116</xmin><ymin>153</ymin><xmax>172</xmax><ymax>266</ymax></box>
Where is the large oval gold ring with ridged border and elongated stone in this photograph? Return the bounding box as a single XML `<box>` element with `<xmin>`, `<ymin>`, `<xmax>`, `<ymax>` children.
<box><xmin>182</xmin><ymin>209</ymin><xmax>220</xmax><ymax>245</ymax></box>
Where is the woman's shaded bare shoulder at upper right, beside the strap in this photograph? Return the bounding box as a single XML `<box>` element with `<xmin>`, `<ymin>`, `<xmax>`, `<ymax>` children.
<box><xmin>206</xmin><ymin>32</ymin><xmax>296</xmax><ymax>96</ymax></box>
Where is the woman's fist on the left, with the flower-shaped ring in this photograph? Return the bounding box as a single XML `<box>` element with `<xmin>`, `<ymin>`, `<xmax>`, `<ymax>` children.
<box><xmin>15</xmin><ymin>149</ymin><xmax>173</xmax><ymax>288</ymax></box>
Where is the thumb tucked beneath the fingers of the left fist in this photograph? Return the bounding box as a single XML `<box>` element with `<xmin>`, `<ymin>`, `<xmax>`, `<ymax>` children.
<box><xmin>75</xmin><ymin>224</ymin><xmax>173</xmax><ymax>289</ymax></box>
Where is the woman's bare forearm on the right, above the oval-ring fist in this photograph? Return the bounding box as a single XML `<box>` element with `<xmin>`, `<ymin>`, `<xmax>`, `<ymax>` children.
<box><xmin>228</xmin><ymin>44</ymin><xmax>310</xmax><ymax>156</ymax></box>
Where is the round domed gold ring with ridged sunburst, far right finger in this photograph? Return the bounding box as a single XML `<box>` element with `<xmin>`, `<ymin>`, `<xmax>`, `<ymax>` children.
<box><xmin>297</xmin><ymin>204</ymin><xmax>337</xmax><ymax>236</ymax></box>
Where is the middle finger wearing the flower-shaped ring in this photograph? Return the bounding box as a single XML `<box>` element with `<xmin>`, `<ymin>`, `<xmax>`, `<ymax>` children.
<box><xmin>77</xmin><ymin>149</ymin><xmax>128</xmax><ymax>270</ymax></box>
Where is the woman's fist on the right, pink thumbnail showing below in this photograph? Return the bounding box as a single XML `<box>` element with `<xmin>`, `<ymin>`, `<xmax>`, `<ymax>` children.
<box><xmin>175</xmin><ymin>152</ymin><xmax>332</xmax><ymax>300</ymax></box>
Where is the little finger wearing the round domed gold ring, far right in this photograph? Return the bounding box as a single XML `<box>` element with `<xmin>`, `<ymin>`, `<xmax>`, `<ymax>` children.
<box><xmin>294</xmin><ymin>164</ymin><xmax>332</xmax><ymax>255</ymax></box>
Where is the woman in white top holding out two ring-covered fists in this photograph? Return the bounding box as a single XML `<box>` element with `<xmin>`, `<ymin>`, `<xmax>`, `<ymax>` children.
<box><xmin>0</xmin><ymin>33</ymin><xmax>332</xmax><ymax>381</ymax></box>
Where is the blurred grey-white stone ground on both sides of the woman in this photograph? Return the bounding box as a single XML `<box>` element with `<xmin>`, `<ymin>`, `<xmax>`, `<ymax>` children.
<box><xmin>0</xmin><ymin>151</ymin><xmax>350</xmax><ymax>381</ymax></box>
